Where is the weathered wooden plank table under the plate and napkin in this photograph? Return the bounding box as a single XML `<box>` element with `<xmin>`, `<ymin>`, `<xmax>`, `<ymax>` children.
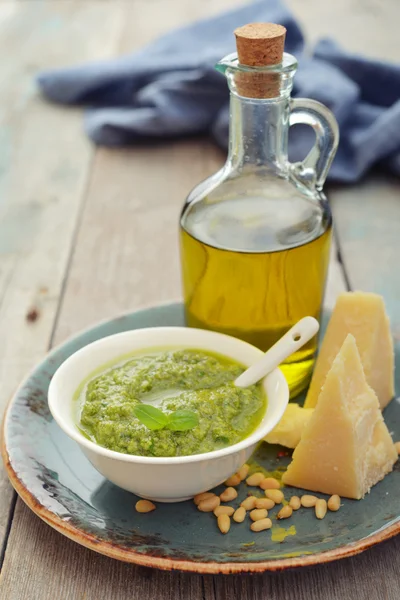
<box><xmin>0</xmin><ymin>0</ymin><xmax>400</xmax><ymax>600</ymax></box>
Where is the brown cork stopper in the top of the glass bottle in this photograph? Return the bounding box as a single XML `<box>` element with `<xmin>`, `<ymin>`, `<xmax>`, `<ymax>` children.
<box><xmin>234</xmin><ymin>23</ymin><xmax>286</xmax><ymax>98</ymax></box>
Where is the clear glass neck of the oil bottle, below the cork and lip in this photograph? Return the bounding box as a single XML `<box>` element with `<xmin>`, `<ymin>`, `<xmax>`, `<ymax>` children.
<box><xmin>228</xmin><ymin>93</ymin><xmax>290</xmax><ymax>173</ymax></box>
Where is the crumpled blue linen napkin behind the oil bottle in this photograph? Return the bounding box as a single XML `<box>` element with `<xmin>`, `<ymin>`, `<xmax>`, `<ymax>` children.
<box><xmin>37</xmin><ymin>0</ymin><xmax>400</xmax><ymax>182</ymax></box>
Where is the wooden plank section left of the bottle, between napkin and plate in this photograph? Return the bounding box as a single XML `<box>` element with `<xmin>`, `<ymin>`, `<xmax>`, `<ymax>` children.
<box><xmin>50</xmin><ymin>140</ymin><xmax>223</xmax><ymax>343</ymax></box>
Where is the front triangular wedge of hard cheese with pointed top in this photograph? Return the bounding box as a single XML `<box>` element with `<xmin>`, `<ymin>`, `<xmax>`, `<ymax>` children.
<box><xmin>282</xmin><ymin>335</ymin><xmax>397</xmax><ymax>499</ymax></box>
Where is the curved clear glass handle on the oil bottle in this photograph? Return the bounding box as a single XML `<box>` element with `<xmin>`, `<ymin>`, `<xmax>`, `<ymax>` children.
<box><xmin>289</xmin><ymin>98</ymin><xmax>339</xmax><ymax>190</ymax></box>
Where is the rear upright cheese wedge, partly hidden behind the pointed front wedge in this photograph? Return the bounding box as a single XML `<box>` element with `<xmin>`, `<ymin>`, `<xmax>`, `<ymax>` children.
<box><xmin>304</xmin><ymin>292</ymin><xmax>394</xmax><ymax>410</ymax></box>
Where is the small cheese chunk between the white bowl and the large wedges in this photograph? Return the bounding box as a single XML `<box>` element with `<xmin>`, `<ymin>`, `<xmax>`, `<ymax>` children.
<box><xmin>264</xmin><ymin>403</ymin><xmax>314</xmax><ymax>448</ymax></box>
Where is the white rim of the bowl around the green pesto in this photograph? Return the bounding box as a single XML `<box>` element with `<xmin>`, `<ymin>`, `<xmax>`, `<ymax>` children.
<box><xmin>47</xmin><ymin>326</ymin><xmax>289</xmax><ymax>464</ymax></box>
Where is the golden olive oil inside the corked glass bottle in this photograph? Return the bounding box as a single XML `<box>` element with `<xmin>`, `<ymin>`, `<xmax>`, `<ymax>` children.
<box><xmin>181</xmin><ymin>198</ymin><xmax>331</xmax><ymax>396</ymax></box>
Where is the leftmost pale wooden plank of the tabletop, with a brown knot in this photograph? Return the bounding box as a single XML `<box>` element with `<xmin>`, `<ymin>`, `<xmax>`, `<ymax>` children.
<box><xmin>0</xmin><ymin>1</ymin><xmax>120</xmax><ymax>547</ymax></box>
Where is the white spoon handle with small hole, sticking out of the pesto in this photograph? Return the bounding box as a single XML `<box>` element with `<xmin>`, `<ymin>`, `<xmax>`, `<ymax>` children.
<box><xmin>235</xmin><ymin>317</ymin><xmax>319</xmax><ymax>388</ymax></box>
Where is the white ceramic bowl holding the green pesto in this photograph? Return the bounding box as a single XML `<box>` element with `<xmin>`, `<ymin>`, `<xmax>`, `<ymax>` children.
<box><xmin>48</xmin><ymin>327</ymin><xmax>289</xmax><ymax>502</ymax></box>
